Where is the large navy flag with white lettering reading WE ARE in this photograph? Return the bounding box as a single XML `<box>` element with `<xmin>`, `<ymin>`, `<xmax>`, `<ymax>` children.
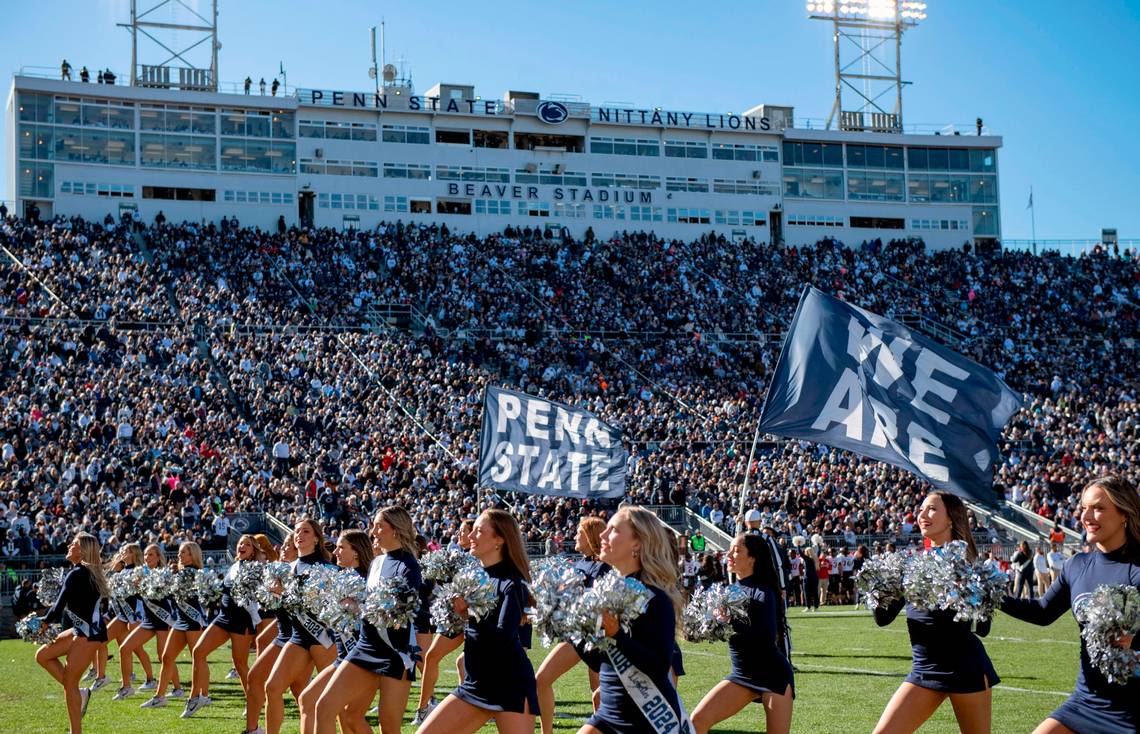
<box><xmin>760</xmin><ymin>286</ymin><xmax>1021</xmax><ymax>505</ymax></box>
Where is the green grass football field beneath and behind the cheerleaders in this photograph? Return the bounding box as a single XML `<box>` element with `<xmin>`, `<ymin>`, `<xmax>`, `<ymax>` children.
<box><xmin>0</xmin><ymin>607</ymin><xmax>1077</xmax><ymax>734</ymax></box>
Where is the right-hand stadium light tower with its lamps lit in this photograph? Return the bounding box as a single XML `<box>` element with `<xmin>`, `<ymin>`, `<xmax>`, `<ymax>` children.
<box><xmin>807</xmin><ymin>0</ymin><xmax>927</xmax><ymax>132</ymax></box>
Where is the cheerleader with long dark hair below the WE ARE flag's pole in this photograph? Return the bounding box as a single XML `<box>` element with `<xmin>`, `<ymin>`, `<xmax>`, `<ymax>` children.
<box><xmin>693</xmin><ymin>535</ymin><xmax>795</xmax><ymax>734</ymax></box>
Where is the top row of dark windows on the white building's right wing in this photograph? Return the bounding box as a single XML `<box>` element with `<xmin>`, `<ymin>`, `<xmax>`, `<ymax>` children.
<box><xmin>783</xmin><ymin>142</ymin><xmax>998</xmax><ymax>173</ymax></box>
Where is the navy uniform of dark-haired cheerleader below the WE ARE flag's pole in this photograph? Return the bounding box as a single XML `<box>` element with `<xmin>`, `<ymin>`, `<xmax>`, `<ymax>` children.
<box><xmin>725</xmin><ymin>576</ymin><xmax>796</xmax><ymax>703</ymax></box>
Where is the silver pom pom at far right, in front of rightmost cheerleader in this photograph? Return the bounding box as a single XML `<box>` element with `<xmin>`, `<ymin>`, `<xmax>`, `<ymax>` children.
<box><xmin>1074</xmin><ymin>585</ymin><xmax>1140</xmax><ymax>685</ymax></box>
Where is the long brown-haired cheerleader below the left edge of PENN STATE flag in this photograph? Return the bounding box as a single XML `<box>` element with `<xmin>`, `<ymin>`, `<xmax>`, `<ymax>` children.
<box><xmin>420</xmin><ymin>509</ymin><xmax>538</xmax><ymax>734</ymax></box>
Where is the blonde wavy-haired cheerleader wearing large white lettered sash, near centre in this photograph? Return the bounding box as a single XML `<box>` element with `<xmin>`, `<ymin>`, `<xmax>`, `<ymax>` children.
<box><xmin>578</xmin><ymin>506</ymin><xmax>689</xmax><ymax>734</ymax></box>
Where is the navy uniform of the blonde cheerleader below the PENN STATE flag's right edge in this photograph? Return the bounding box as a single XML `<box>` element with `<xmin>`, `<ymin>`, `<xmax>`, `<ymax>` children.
<box><xmin>586</xmin><ymin>573</ymin><xmax>682</xmax><ymax>734</ymax></box>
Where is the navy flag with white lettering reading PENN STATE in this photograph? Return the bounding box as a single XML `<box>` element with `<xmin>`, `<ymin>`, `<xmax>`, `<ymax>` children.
<box><xmin>479</xmin><ymin>386</ymin><xmax>628</xmax><ymax>499</ymax></box>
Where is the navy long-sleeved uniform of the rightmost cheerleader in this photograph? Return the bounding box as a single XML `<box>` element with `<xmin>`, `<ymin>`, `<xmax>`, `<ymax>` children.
<box><xmin>1001</xmin><ymin>545</ymin><xmax>1140</xmax><ymax>734</ymax></box>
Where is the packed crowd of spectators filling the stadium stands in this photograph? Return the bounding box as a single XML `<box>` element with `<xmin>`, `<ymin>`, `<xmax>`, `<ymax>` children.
<box><xmin>0</xmin><ymin>211</ymin><xmax>1140</xmax><ymax>567</ymax></box>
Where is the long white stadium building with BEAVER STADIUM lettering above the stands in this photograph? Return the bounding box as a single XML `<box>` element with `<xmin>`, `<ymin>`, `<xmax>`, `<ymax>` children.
<box><xmin>5</xmin><ymin>76</ymin><xmax>1001</xmax><ymax>248</ymax></box>
